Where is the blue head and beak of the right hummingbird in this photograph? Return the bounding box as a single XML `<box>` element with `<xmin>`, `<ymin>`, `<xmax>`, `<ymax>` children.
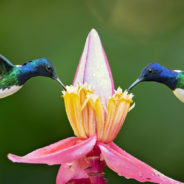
<box><xmin>128</xmin><ymin>63</ymin><xmax>177</xmax><ymax>91</ymax></box>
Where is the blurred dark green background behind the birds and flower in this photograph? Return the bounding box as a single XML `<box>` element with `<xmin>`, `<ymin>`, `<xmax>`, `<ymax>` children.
<box><xmin>0</xmin><ymin>0</ymin><xmax>184</xmax><ymax>184</ymax></box>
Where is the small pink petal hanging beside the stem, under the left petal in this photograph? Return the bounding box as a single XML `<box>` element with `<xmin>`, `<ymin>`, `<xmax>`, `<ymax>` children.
<box><xmin>56</xmin><ymin>159</ymin><xmax>89</xmax><ymax>184</ymax></box>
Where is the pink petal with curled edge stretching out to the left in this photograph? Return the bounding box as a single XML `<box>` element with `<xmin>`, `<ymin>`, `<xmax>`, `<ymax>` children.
<box><xmin>8</xmin><ymin>136</ymin><xmax>96</xmax><ymax>165</ymax></box>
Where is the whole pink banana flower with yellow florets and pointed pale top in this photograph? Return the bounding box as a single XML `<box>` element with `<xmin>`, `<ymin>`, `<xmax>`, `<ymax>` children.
<box><xmin>8</xmin><ymin>29</ymin><xmax>180</xmax><ymax>184</ymax></box>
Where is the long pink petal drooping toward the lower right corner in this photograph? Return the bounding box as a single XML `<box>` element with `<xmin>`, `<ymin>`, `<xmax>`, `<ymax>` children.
<box><xmin>99</xmin><ymin>143</ymin><xmax>181</xmax><ymax>184</ymax></box>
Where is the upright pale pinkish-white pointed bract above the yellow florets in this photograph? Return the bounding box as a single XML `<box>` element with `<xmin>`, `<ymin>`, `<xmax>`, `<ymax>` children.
<box><xmin>73</xmin><ymin>29</ymin><xmax>114</xmax><ymax>102</ymax></box>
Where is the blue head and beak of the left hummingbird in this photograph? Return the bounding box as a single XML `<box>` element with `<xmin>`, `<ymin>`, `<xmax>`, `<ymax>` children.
<box><xmin>21</xmin><ymin>58</ymin><xmax>65</xmax><ymax>89</ymax></box>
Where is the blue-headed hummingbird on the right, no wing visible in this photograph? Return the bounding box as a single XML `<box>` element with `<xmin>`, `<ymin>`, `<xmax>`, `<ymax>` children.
<box><xmin>128</xmin><ymin>63</ymin><xmax>184</xmax><ymax>103</ymax></box>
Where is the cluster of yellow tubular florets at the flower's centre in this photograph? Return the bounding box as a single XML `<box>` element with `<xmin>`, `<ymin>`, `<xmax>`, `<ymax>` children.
<box><xmin>63</xmin><ymin>83</ymin><xmax>133</xmax><ymax>143</ymax></box>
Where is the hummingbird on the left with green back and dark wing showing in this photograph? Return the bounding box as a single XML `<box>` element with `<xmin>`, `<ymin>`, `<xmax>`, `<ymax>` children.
<box><xmin>0</xmin><ymin>55</ymin><xmax>66</xmax><ymax>98</ymax></box>
